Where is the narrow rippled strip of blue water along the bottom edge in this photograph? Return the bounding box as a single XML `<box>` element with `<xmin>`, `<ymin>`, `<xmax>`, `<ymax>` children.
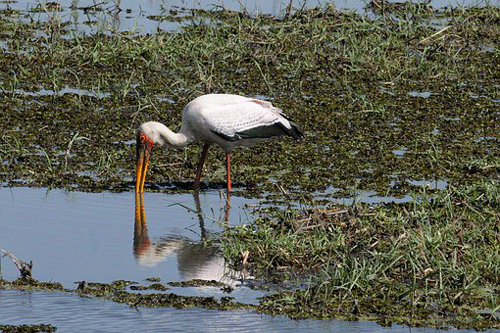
<box><xmin>0</xmin><ymin>291</ymin><xmax>493</xmax><ymax>333</ymax></box>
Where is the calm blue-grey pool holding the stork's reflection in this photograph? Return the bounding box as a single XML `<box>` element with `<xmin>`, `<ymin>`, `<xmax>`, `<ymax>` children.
<box><xmin>0</xmin><ymin>188</ymin><xmax>260</xmax><ymax>301</ymax></box>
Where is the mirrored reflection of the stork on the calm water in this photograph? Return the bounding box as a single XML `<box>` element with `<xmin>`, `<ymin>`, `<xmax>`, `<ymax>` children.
<box><xmin>133</xmin><ymin>193</ymin><xmax>245</xmax><ymax>286</ymax></box>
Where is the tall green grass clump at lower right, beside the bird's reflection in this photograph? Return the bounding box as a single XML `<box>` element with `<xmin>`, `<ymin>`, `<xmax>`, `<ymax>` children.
<box><xmin>222</xmin><ymin>180</ymin><xmax>500</xmax><ymax>328</ymax></box>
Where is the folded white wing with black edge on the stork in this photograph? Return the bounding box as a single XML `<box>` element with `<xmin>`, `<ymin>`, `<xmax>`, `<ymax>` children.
<box><xmin>204</xmin><ymin>99</ymin><xmax>294</xmax><ymax>141</ymax></box>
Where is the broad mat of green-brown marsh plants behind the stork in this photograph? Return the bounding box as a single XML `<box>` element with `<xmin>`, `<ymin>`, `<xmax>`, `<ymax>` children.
<box><xmin>0</xmin><ymin>7</ymin><xmax>500</xmax><ymax>199</ymax></box>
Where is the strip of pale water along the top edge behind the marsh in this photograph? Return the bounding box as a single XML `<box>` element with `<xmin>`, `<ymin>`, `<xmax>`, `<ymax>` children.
<box><xmin>0</xmin><ymin>0</ymin><xmax>494</xmax><ymax>37</ymax></box>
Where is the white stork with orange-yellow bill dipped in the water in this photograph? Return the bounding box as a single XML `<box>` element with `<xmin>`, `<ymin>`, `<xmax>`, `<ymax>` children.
<box><xmin>135</xmin><ymin>94</ymin><xmax>303</xmax><ymax>193</ymax></box>
